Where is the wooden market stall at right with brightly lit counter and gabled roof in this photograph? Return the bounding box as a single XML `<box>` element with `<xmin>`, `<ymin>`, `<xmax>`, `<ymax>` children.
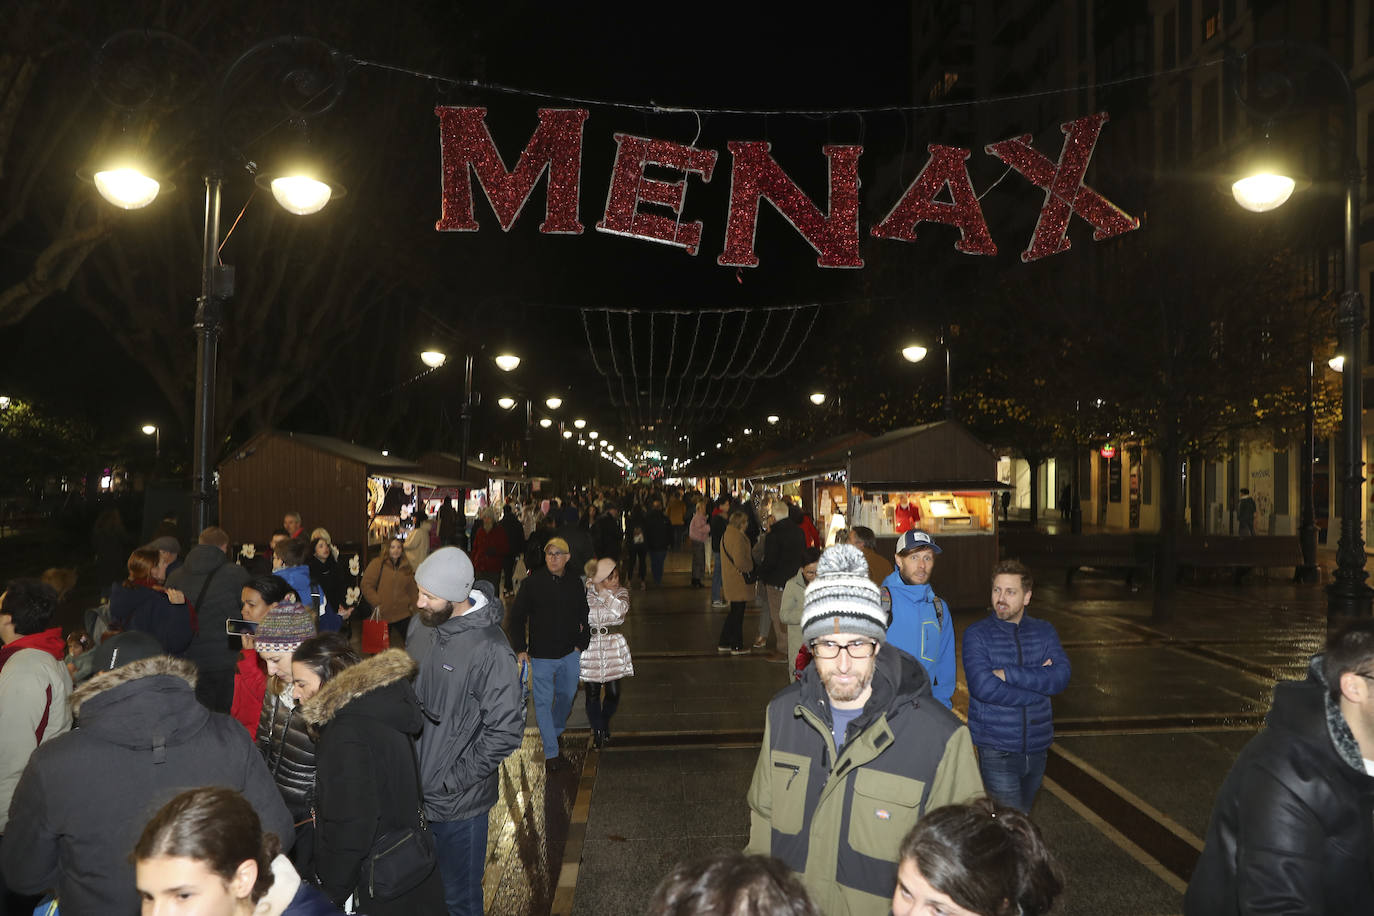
<box><xmin>842</xmin><ymin>420</ymin><xmax>1006</xmax><ymax>607</ymax></box>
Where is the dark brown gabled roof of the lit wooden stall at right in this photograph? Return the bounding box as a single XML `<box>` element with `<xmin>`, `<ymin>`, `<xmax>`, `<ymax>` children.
<box><xmin>849</xmin><ymin>420</ymin><xmax>1007</xmax><ymax>492</ymax></box>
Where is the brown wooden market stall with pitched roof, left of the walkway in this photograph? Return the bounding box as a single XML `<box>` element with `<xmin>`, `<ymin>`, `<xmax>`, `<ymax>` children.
<box><xmin>218</xmin><ymin>430</ymin><xmax>473</xmax><ymax>548</ymax></box>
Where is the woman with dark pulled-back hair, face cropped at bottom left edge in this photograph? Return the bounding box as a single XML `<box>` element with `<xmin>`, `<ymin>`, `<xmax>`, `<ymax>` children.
<box><xmin>133</xmin><ymin>787</ymin><xmax>339</xmax><ymax>916</ymax></box>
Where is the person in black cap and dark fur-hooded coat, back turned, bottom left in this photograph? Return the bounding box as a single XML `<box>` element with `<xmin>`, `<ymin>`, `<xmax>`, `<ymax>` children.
<box><xmin>3</xmin><ymin>633</ymin><xmax>295</xmax><ymax>916</ymax></box>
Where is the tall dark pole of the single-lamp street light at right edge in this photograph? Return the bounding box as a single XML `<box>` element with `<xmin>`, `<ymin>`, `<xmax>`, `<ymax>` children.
<box><xmin>1323</xmin><ymin>75</ymin><xmax>1374</xmax><ymax>628</ymax></box>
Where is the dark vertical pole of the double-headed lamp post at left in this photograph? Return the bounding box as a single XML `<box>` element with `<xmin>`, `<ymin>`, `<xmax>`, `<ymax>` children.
<box><xmin>191</xmin><ymin>170</ymin><xmax>223</xmax><ymax>534</ymax></box>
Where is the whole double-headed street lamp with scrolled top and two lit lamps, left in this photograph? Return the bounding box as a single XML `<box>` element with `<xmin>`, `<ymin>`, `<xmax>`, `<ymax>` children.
<box><xmin>89</xmin><ymin>29</ymin><xmax>349</xmax><ymax>531</ymax></box>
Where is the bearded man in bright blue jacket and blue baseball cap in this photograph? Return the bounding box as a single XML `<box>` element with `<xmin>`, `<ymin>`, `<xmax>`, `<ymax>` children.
<box><xmin>879</xmin><ymin>529</ymin><xmax>956</xmax><ymax>709</ymax></box>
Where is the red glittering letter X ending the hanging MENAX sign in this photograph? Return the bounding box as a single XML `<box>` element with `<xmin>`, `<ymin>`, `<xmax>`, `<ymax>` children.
<box><xmin>985</xmin><ymin>111</ymin><xmax>1140</xmax><ymax>262</ymax></box>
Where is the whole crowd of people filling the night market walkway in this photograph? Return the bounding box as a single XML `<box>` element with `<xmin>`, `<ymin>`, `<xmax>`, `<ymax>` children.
<box><xmin>0</xmin><ymin>488</ymin><xmax>1374</xmax><ymax>916</ymax></box>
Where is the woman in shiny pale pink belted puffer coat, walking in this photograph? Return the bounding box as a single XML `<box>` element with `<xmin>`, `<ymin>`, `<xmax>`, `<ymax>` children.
<box><xmin>581</xmin><ymin>556</ymin><xmax>635</xmax><ymax>747</ymax></box>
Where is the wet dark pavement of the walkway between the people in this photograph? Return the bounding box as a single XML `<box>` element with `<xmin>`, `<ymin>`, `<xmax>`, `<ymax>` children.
<box><xmin>484</xmin><ymin>553</ymin><xmax>1326</xmax><ymax>916</ymax></box>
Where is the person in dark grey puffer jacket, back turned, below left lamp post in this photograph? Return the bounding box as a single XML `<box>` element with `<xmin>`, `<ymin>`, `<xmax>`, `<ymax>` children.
<box><xmin>168</xmin><ymin>526</ymin><xmax>249</xmax><ymax>713</ymax></box>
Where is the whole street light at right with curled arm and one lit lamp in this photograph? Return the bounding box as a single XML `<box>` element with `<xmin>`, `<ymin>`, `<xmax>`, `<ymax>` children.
<box><xmin>1234</xmin><ymin>41</ymin><xmax>1374</xmax><ymax>626</ymax></box>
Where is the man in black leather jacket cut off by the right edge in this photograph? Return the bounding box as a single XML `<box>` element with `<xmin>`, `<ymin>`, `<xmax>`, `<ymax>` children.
<box><xmin>1183</xmin><ymin>618</ymin><xmax>1374</xmax><ymax>916</ymax></box>
